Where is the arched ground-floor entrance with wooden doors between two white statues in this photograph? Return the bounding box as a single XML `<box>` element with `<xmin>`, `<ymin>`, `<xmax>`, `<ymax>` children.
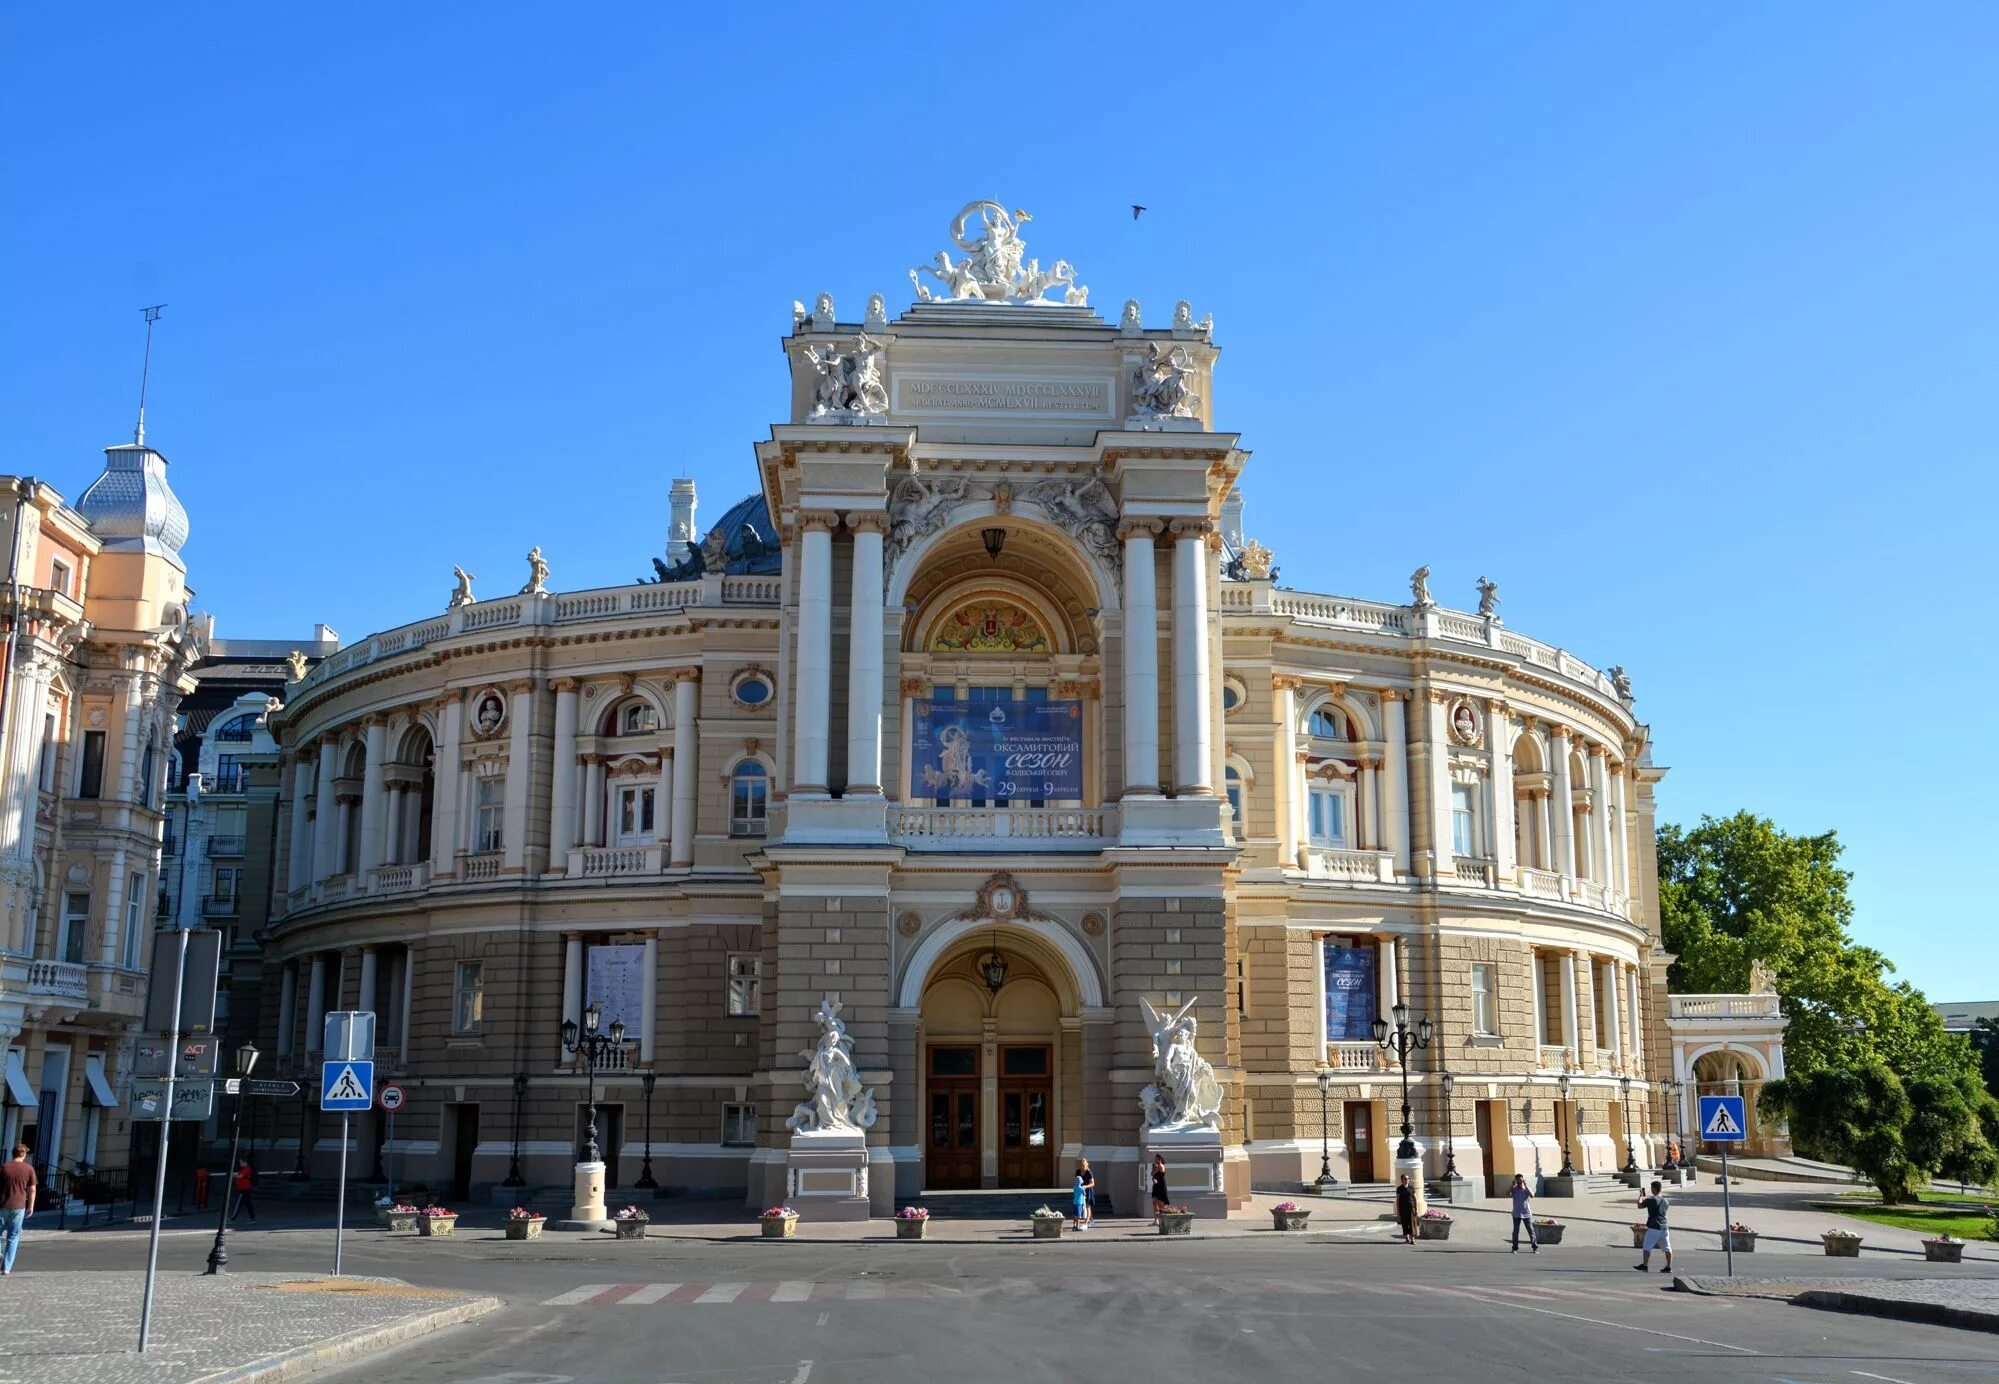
<box><xmin>918</xmin><ymin>924</ymin><xmax>1083</xmax><ymax>1190</ymax></box>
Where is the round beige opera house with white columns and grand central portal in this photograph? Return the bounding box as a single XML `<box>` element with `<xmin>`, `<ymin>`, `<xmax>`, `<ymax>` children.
<box><xmin>262</xmin><ymin>206</ymin><xmax>1671</xmax><ymax>1210</ymax></box>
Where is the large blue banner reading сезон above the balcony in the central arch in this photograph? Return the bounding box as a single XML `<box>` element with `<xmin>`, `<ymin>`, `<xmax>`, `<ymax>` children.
<box><xmin>910</xmin><ymin>700</ymin><xmax>1083</xmax><ymax>802</ymax></box>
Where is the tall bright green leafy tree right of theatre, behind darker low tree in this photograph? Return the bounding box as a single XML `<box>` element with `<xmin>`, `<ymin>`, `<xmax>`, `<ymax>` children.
<box><xmin>1659</xmin><ymin>812</ymin><xmax>1977</xmax><ymax>1080</ymax></box>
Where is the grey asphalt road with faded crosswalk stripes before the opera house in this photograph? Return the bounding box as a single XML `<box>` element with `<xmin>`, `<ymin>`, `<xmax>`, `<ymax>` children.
<box><xmin>27</xmin><ymin>1230</ymin><xmax>1999</xmax><ymax>1384</ymax></box>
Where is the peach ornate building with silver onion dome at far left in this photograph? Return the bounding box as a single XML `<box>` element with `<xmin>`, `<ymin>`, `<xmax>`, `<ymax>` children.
<box><xmin>0</xmin><ymin>444</ymin><xmax>200</xmax><ymax>1172</ymax></box>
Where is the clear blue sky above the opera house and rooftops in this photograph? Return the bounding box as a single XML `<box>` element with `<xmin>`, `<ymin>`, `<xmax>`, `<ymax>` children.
<box><xmin>0</xmin><ymin>2</ymin><xmax>1999</xmax><ymax>1000</ymax></box>
